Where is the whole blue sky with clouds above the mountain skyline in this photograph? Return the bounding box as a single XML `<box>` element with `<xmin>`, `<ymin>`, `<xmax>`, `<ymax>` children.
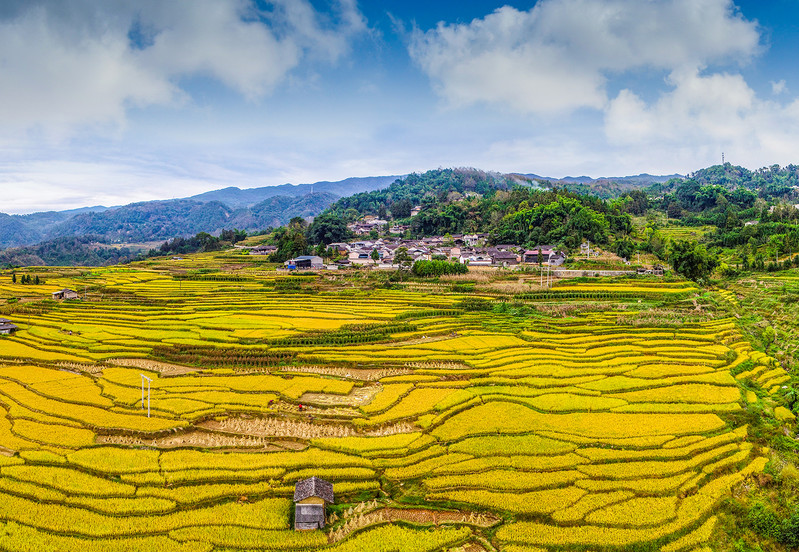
<box><xmin>0</xmin><ymin>0</ymin><xmax>799</xmax><ymax>213</ymax></box>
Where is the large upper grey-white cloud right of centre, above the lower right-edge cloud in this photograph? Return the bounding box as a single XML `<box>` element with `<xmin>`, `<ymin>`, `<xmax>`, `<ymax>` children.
<box><xmin>409</xmin><ymin>0</ymin><xmax>760</xmax><ymax>114</ymax></box>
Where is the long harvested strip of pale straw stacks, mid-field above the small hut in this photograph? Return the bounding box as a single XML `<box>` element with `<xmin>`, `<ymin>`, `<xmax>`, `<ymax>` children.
<box><xmin>202</xmin><ymin>417</ymin><xmax>419</xmax><ymax>440</ymax></box>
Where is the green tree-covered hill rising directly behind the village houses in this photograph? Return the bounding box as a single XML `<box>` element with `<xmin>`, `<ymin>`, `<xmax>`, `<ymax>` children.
<box><xmin>322</xmin><ymin>169</ymin><xmax>636</xmax><ymax>252</ymax></box>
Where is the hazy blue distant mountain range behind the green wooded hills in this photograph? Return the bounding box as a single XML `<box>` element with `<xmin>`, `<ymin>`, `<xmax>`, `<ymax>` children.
<box><xmin>0</xmin><ymin>173</ymin><xmax>678</xmax><ymax>249</ymax></box>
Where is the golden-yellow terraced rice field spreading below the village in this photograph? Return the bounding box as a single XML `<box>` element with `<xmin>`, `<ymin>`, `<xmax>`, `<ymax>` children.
<box><xmin>0</xmin><ymin>262</ymin><xmax>786</xmax><ymax>552</ymax></box>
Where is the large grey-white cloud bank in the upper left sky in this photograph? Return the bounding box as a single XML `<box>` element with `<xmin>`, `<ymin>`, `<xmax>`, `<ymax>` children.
<box><xmin>0</xmin><ymin>0</ymin><xmax>366</xmax><ymax>130</ymax></box>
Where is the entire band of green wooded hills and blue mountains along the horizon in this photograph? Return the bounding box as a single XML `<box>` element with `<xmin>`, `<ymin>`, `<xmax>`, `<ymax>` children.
<box><xmin>7</xmin><ymin>163</ymin><xmax>799</xmax><ymax>263</ymax></box>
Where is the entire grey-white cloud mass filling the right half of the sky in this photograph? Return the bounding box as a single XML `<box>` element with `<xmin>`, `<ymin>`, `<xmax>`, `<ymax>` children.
<box><xmin>408</xmin><ymin>0</ymin><xmax>799</xmax><ymax>169</ymax></box>
